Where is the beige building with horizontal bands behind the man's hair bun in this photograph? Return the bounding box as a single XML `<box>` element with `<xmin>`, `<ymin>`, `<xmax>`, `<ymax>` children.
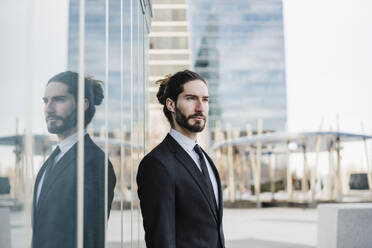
<box><xmin>149</xmin><ymin>0</ymin><xmax>190</xmax><ymax>147</ymax></box>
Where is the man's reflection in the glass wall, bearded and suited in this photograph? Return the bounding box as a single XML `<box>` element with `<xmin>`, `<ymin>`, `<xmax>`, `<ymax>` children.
<box><xmin>32</xmin><ymin>71</ymin><xmax>116</xmax><ymax>248</ymax></box>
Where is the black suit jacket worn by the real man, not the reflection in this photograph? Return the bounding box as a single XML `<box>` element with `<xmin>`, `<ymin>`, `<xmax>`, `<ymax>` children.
<box><xmin>137</xmin><ymin>134</ymin><xmax>225</xmax><ymax>248</ymax></box>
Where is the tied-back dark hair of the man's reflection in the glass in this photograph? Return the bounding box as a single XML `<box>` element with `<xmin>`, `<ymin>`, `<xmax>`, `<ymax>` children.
<box><xmin>47</xmin><ymin>71</ymin><xmax>104</xmax><ymax>127</ymax></box>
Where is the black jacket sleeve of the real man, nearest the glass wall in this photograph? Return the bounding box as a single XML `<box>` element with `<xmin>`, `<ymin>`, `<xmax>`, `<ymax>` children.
<box><xmin>137</xmin><ymin>157</ymin><xmax>176</xmax><ymax>248</ymax></box>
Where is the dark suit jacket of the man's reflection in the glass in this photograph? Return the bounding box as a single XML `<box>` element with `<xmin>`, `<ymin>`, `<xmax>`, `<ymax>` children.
<box><xmin>32</xmin><ymin>135</ymin><xmax>116</xmax><ymax>248</ymax></box>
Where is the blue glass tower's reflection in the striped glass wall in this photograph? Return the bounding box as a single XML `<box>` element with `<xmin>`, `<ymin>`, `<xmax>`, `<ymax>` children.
<box><xmin>68</xmin><ymin>0</ymin><xmax>151</xmax><ymax>133</ymax></box>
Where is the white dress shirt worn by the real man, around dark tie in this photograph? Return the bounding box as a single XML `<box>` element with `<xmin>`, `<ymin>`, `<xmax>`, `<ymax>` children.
<box><xmin>169</xmin><ymin>128</ymin><xmax>218</xmax><ymax>207</ymax></box>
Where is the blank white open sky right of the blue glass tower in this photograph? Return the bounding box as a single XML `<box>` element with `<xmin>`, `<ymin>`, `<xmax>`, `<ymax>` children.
<box><xmin>283</xmin><ymin>0</ymin><xmax>372</xmax><ymax>133</ymax></box>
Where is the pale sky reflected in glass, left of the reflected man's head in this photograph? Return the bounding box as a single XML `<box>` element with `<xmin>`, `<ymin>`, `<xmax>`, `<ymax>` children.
<box><xmin>0</xmin><ymin>0</ymin><xmax>68</xmax><ymax>136</ymax></box>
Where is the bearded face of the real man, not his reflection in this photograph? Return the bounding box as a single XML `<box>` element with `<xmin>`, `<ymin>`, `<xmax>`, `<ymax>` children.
<box><xmin>174</xmin><ymin>80</ymin><xmax>209</xmax><ymax>133</ymax></box>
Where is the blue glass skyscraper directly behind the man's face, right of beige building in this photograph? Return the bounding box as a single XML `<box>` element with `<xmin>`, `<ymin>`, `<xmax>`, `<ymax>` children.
<box><xmin>188</xmin><ymin>0</ymin><xmax>286</xmax><ymax>137</ymax></box>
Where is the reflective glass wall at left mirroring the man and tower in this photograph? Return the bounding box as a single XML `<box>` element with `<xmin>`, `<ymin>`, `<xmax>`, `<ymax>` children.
<box><xmin>0</xmin><ymin>0</ymin><xmax>152</xmax><ymax>248</ymax></box>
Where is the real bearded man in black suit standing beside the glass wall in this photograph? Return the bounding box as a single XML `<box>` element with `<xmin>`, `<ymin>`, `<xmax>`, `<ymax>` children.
<box><xmin>137</xmin><ymin>70</ymin><xmax>225</xmax><ymax>248</ymax></box>
